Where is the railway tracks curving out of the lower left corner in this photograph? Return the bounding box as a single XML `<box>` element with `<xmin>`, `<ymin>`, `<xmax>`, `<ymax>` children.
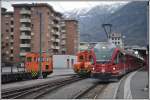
<box><xmin>2</xmin><ymin>76</ymin><xmax>85</xmax><ymax>99</ymax></box>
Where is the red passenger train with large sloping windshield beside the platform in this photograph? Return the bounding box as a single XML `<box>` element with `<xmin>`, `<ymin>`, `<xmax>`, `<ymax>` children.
<box><xmin>91</xmin><ymin>43</ymin><xmax>144</xmax><ymax>80</ymax></box>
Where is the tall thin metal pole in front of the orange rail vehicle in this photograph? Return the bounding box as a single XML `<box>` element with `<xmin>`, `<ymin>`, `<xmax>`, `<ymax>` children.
<box><xmin>39</xmin><ymin>13</ymin><xmax>43</xmax><ymax>79</ymax></box>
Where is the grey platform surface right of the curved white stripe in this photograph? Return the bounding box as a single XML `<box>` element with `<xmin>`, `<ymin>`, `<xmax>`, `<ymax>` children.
<box><xmin>130</xmin><ymin>69</ymin><xmax>149</xmax><ymax>99</ymax></box>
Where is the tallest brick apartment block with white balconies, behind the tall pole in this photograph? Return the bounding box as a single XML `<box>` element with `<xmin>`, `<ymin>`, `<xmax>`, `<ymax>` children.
<box><xmin>12</xmin><ymin>3</ymin><xmax>62</xmax><ymax>61</ymax></box>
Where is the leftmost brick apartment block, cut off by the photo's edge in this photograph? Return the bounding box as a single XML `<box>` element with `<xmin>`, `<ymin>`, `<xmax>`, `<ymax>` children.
<box><xmin>1</xmin><ymin>8</ymin><xmax>14</xmax><ymax>63</ymax></box>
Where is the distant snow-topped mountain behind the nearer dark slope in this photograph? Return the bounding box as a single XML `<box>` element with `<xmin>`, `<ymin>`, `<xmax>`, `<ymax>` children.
<box><xmin>64</xmin><ymin>3</ymin><xmax>125</xmax><ymax>41</ymax></box>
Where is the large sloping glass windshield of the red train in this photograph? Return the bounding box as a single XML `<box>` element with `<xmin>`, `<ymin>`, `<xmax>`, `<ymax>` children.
<box><xmin>94</xmin><ymin>43</ymin><xmax>115</xmax><ymax>63</ymax></box>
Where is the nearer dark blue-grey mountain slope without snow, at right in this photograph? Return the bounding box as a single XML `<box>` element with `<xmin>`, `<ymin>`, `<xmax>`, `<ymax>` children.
<box><xmin>107</xmin><ymin>1</ymin><xmax>148</xmax><ymax>46</ymax></box>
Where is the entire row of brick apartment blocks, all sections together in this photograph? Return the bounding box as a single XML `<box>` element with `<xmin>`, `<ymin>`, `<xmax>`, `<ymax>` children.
<box><xmin>2</xmin><ymin>3</ymin><xmax>79</xmax><ymax>63</ymax></box>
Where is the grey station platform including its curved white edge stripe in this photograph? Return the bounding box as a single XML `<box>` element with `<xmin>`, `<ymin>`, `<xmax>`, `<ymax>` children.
<box><xmin>116</xmin><ymin>68</ymin><xmax>149</xmax><ymax>99</ymax></box>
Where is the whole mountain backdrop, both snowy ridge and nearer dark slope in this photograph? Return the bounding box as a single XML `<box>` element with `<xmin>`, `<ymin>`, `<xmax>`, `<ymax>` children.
<box><xmin>65</xmin><ymin>1</ymin><xmax>147</xmax><ymax>46</ymax></box>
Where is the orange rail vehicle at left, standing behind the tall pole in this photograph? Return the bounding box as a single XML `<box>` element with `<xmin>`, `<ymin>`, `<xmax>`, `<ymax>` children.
<box><xmin>25</xmin><ymin>52</ymin><xmax>53</xmax><ymax>78</ymax></box>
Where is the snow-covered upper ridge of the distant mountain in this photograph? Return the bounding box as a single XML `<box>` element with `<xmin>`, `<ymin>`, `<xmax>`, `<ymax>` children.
<box><xmin>64</xmin><ymin>3</ymin><xmax>126</xmax><ymax>19</ymax></box>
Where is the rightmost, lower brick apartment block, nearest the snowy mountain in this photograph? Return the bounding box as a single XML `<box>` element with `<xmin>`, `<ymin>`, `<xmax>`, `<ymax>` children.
<box><xmin>61</xmin><ymin>19</ymin><xmax>79</xmax><ymax>55</ymax></box>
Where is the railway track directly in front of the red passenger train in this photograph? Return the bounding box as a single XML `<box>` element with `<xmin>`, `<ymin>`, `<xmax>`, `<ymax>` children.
<box><xmin>73</xmin><ymin>83</ymin><xmax>108</xmax><ymax>99</ymax></box>
